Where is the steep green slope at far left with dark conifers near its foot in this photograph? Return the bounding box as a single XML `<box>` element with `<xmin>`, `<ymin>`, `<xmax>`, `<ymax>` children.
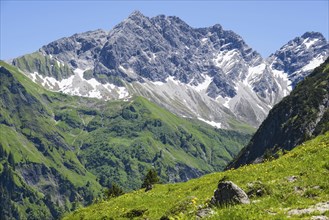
<box><xmin>0</xmin><ymin>62</ymin><xmax>101</xmax><ymax>219</ymax></box>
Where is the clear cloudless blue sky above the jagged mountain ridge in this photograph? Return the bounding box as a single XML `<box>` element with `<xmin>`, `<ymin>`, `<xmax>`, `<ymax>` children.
<box><xmin>0</xmin><ymin>0</ymin><xmax>329</xmax><ymax>60</ymax></box>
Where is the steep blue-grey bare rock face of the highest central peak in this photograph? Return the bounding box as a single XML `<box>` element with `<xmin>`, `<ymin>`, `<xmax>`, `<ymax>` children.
<box><xmin>95</xmin><ymin>12</ymin><xmax>262</xmax><ymax>93</ymax></box>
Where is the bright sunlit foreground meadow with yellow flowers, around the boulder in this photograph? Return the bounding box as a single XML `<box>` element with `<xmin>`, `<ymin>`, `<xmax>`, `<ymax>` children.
<box><xmin>64</xmin><ymin>132</ymin><xmax>329</xmax><ymax>220</ymax></box>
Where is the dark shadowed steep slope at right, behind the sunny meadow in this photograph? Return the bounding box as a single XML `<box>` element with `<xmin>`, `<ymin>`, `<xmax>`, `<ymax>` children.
<box><xmin>228</xmin><ymin>59</ymin><xmax>329</xmax><ymax>168</ymax></box>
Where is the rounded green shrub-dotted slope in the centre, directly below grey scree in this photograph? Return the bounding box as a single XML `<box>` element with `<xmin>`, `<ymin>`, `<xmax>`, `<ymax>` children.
<box><xmin>69</xmin><ymin>97</ymin><xmax>249</xmax><ymax>189</ymax></box>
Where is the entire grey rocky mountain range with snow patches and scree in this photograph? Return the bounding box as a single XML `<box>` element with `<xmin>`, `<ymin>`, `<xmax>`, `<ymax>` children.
<box><xmin>12</xmin><ymin>11</ymin><xmax>329</xmax><ymax>129</ymax></box>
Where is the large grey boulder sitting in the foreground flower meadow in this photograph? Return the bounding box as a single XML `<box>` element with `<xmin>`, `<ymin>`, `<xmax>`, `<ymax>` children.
<box><xmin>211</xmin><ymin>181</ymin><xmax>250</xmax><ymax>206</ymax></box>
